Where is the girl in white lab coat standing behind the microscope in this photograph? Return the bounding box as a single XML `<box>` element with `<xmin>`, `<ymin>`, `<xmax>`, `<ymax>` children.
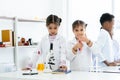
<box><xmin>23</xmin><ymin>15</ymin><xmax>67</xmax><ymax>70</ymax></box>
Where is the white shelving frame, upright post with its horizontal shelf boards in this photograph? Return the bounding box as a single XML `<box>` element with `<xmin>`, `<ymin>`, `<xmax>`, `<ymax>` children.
<box><xmin>0</xmin><ymin>16</ymin><xmax>46</xmax><ymax>68</ymax></box>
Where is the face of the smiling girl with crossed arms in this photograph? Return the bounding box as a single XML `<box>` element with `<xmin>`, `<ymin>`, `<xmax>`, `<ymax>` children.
<box><xmin>73</xmin><ymin>26</ymin><xmax>85</xmax><ymax>39</ymax></box>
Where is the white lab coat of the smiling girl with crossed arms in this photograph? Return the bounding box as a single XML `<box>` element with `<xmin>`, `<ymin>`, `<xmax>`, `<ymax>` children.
<box><xmin>67</xmin><ymin>38</ymin><xmax>93</xmax><ymax>71</ymax></box>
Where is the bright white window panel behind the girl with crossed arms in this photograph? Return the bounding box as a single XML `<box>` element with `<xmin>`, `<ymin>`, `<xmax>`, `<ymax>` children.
<box><xmin>68</xmin><ymin>0</ymin><xmax>112</xmax><ymax>41</ymax></box>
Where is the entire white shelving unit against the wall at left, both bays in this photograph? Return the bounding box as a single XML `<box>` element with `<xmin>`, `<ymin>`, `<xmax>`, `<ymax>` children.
<box><xmin>0</xmin><ymin>17</ymin><xmax>47</xmax><ymax>69</ymax></box>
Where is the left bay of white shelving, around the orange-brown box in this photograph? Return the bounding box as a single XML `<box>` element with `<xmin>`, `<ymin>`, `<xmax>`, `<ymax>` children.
<box><xmin>0</xmin><ymin>16</ymin><xmax>15</xmax><ymax>72</ymax></box>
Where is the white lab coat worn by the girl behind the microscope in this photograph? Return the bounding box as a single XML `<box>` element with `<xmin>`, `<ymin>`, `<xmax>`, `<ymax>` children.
<box><xmin>27</xmin><ymin>34</ymin><xmax>66</xmax><ymax>70</ymax></box>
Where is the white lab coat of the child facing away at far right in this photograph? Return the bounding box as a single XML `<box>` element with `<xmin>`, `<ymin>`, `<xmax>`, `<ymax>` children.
<box><xmin>91</xmin><ymin>29</ymin><xmax>114</xmax><ymax>67</ymax></box>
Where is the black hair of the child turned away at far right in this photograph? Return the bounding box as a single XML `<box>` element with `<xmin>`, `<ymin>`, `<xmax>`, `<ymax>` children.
<box><xmin>100</xmin><ymin>13</ymin><xmax>114</xmax><ymax>25</ymax></box>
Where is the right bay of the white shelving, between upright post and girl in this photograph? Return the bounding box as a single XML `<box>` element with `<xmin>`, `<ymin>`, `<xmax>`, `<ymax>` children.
<box><xmin>15</xmin><ymin>19</ymin><xmax>47</xmax><ymax>68</ymax></box>
